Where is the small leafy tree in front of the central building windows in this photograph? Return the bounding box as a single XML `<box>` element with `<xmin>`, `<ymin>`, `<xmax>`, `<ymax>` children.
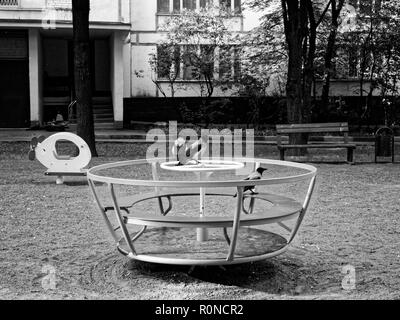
<box><xmin>155</xmin><ymin>6</ymin><xmax>232</xmax><ymax>97</ymax></box>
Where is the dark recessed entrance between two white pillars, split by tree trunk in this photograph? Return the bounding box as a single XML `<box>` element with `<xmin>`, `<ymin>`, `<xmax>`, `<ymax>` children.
<box><xmin>43</xmin><ymin>37</ymin><xmax>113</xmax><ymax>122</ymax></box>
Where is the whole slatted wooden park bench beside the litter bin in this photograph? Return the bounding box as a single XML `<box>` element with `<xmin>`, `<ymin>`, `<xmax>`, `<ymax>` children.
<box><xmin>276</xmin><ymin>122</ymin><xmax>356</xmax><ymax>164</ymax></box>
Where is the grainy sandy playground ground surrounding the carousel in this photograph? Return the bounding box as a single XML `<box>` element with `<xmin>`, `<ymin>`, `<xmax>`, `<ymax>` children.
<box><xmin>0</xmin><ymin>143</ymin><xmax>400</xmax><ymax>299</ymax></box>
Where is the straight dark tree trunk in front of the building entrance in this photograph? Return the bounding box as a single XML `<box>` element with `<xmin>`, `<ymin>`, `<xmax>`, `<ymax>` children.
<box><xmin>72</xmin><ymin>0</ymin><xmax>98</xmax><ymax>157</ymax></box>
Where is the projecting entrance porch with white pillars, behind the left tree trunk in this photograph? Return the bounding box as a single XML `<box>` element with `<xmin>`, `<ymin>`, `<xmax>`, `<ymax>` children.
<box><xmin>0</xmin><ymin>0</ymin><xmax>131</xmax><ymax>128</ymax></box>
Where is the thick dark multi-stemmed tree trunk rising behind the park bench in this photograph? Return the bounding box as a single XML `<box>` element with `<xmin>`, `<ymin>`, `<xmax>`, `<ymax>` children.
<box><xmin>250</xmin><ymin>0</ymin><xmax>330</xmax><ymax>154</ymax></box>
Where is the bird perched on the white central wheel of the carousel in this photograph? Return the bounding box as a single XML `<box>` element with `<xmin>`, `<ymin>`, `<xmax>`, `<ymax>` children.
<box><xmin>172</xmin><ymin>135</ymin><xmax>208</xmax><ymax>166</ymax></box>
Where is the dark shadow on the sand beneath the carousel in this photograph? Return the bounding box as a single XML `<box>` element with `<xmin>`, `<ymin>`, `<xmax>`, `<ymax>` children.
<box><xmin>126</xmin><ymin>258</ymin><xmax>316</xmax><ymax>295</ymax></box>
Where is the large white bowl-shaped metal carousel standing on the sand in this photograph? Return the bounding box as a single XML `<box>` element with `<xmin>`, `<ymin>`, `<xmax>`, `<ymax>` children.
<box><xmin>87</xmin><ymin>158</ymin><xmax>317</xmax><ymax>265</ymax></box>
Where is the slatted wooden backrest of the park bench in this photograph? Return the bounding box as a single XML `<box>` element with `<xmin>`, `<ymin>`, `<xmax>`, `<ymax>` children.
<box><xmin>276</xmin><ymin>122</ymin><xmax>349</xmax><ymax>143</ymax></box>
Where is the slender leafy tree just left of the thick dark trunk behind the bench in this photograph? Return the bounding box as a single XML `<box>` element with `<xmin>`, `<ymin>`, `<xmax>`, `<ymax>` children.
<box><xmin>231</xmin><ymin>2</ymin><xmax>287</xmax><ymax>128</ymax></box>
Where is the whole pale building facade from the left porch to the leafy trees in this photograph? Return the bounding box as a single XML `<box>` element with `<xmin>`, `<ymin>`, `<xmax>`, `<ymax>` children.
<box><xmin>0</xmin><ymin>0</ymin><xmax>250</xmax><ymax>128</ymax></box>
